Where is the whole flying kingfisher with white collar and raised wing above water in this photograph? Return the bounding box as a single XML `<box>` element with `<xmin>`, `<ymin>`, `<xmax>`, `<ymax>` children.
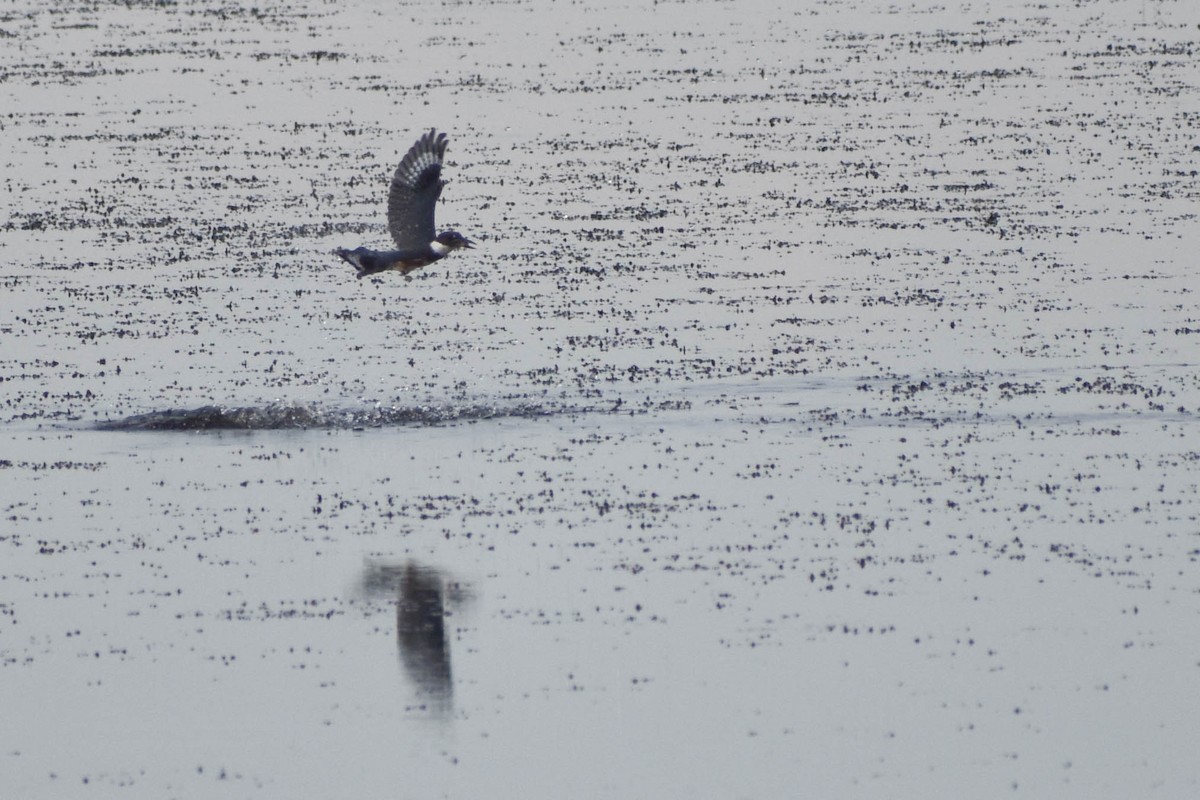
<box><xmin>334</xmin><ymin>128</ymin><xmax>475</xmax><ymax>278</ymax></box>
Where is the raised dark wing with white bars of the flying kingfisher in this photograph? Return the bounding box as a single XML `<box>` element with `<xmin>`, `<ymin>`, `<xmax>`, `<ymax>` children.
<box><xmin>388</xmin><ymin>128</ymin><xmax>449</xmax><ymax>249</ymax></box>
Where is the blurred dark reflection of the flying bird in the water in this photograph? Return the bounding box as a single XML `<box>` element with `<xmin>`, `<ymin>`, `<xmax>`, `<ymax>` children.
<box><xmin>352</xmin><ymin>560</ymin><xmax>463</xmax><ymax>716</ymax></box>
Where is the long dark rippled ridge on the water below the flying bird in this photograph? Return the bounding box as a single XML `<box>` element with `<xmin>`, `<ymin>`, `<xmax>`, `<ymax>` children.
<box><xmin>96</xmin><ymin>403</ymin><xmax>576</xmax><ymax>431</ymax></box>
